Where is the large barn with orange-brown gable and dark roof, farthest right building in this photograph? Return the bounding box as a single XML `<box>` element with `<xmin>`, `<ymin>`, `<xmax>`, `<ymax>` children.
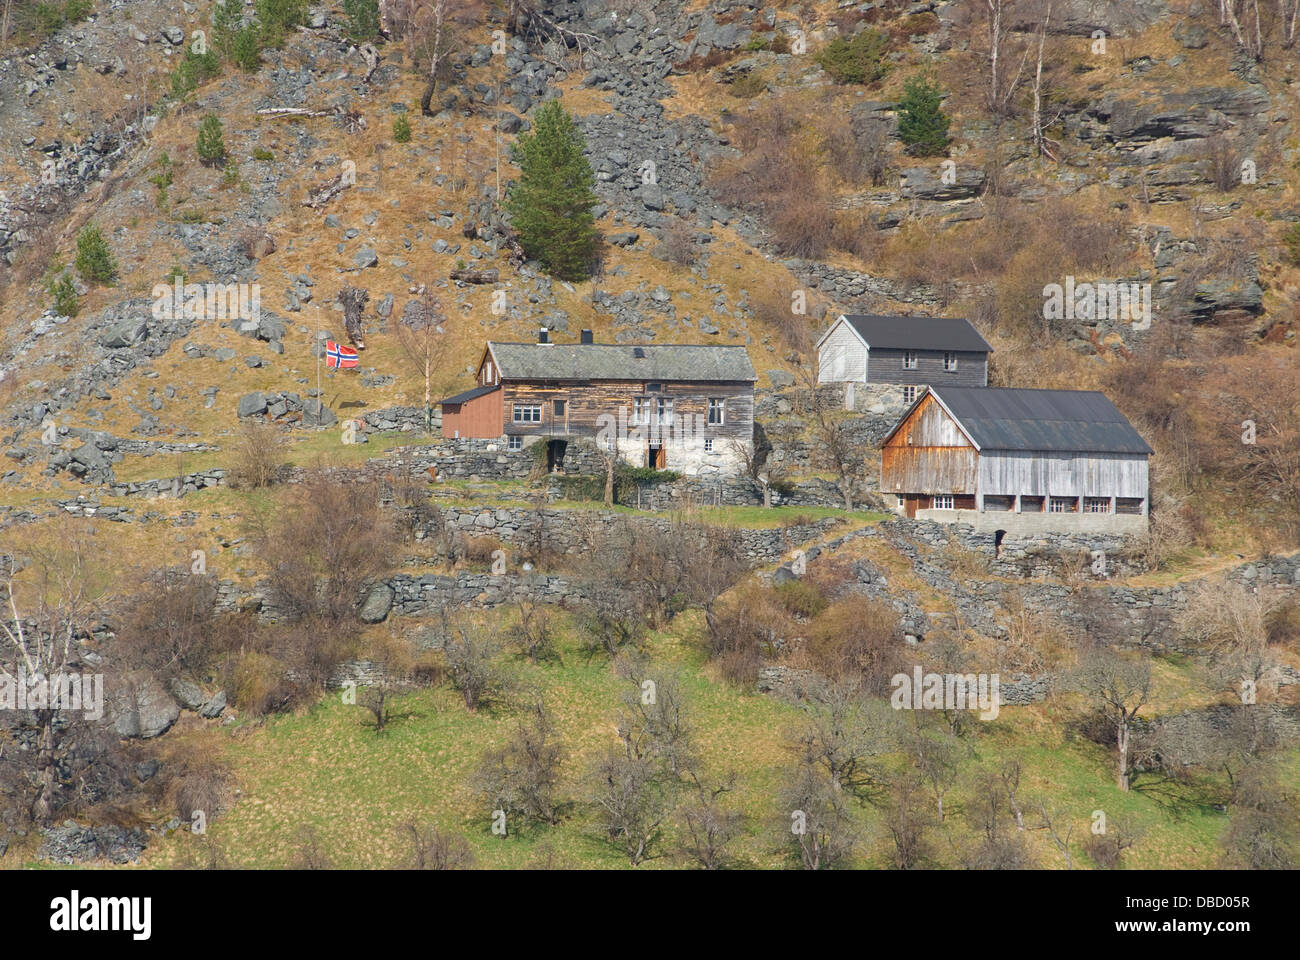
<box><xmin>880</xmin><ymin>386</ymin><xmax>1152</xmax><ymax>535</ymax></box>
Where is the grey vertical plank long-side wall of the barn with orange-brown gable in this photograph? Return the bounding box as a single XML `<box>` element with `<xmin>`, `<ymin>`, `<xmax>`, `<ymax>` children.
<box><xmin>979</xmin><ymin>451</ymin><xmax>1148</xmax><ymax>497</ymax></box>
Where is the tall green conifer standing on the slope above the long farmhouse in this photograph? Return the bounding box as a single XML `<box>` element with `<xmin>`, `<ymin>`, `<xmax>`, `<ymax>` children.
<box><xmin>506</xmin><ymin>100</ymin><xmax>597</xmax><ymax>280</ymax></box>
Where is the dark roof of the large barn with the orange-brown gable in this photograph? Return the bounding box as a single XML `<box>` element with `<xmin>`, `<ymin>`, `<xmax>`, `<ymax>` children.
<box><xmin>930</xmin><ymin>386</ymin><xmax>1153</xmax><ymax>454</ymax></box>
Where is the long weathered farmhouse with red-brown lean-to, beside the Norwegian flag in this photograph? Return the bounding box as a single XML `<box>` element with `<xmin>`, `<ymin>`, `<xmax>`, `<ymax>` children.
<box><xmin>442</xmin><ymin>328</ymin><xmax>755</xmax><ymax>476</ymax></box>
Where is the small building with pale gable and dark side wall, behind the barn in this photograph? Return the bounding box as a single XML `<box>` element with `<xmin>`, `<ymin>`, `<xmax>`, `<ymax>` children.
<box><xmin>816</xmin><ymin>315</ymin><xmax>993</xmax><ymax>412</ymax></box>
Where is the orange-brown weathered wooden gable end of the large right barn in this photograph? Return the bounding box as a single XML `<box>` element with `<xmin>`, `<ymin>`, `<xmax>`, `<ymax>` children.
<box><xmin>880</xmin><ymin>397</ymin><xmax>978</xmax><ymax>494</ymax></box>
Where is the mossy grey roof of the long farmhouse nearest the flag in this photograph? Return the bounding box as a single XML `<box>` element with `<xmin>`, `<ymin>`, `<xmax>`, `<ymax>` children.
<box><xmin>488</xmin><ymin>341</ymin><xmax>758</xmax><ymax>382</ymax></box>
